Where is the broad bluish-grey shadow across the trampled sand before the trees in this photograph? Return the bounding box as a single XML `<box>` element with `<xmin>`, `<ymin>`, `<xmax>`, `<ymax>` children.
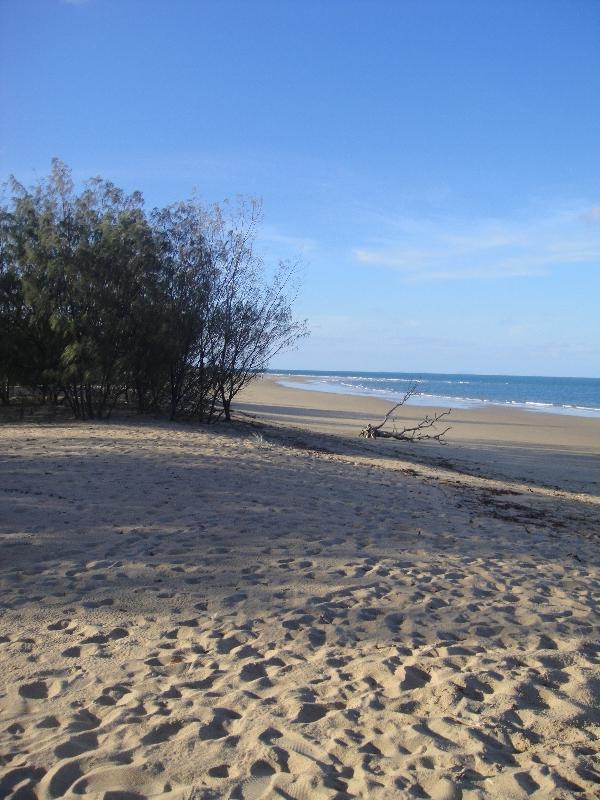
<box><xmin>0</xmin><ymin>421</ymin><xmax>600</xmax><ymax>647</ymax></box>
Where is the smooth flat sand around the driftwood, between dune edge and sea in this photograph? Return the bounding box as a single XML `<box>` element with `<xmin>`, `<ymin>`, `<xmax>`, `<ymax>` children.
<box><xmin>235</xmin><ymin>375</ymin><xmax>600</xmax><ymax>497</ymax></box>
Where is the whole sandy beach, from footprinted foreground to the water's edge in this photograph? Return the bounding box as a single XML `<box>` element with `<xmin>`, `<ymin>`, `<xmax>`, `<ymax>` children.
<box><xmin>0</xmin><ymin>377</ymin><xmax>600</xmax><ymax>800</ymax></box>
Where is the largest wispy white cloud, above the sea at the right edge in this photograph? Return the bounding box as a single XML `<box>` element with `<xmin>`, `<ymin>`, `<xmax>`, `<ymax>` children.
<box><xmin>353</xmin><ymin>207</ymin><xmax>600</xmax><ymax>281</ymax></box>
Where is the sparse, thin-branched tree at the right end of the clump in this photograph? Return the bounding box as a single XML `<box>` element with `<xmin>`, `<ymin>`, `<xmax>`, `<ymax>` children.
<box><xmin>153</xmin><ymin>200</ymin><xmax>306</xmax><ymax>422</ymax></box>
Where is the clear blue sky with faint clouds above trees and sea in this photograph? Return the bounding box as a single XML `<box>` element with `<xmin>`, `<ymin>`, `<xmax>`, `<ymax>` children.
<box><xmin>0</xmin><ymin>0</ymin><xmax>600</xmax><ymax>377</ymax></box>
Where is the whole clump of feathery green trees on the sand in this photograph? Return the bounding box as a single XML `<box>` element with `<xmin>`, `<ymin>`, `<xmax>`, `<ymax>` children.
<box><xmin>0</xmin><ymin>160</ymin><xmax>306</xmax><ymax>422</ymax></box>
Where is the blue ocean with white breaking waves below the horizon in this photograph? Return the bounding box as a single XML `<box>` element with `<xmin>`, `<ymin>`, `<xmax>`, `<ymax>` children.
<box><xmin>268</xmin><ymin>370</ymin><xmax>600</xmax><ymax>417</ymax></box>
